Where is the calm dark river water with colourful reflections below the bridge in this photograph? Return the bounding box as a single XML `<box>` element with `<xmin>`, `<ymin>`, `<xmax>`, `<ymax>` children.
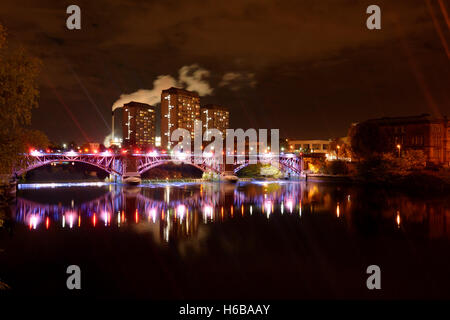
<box><xmin>0</xmin><ymin>182</ymin><xmax>450</xmax><ymax>299</ymax></box>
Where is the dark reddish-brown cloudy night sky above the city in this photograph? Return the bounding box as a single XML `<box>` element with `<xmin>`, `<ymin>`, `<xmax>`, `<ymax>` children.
<box><xmin>0</xmin><ymin>0</ymin><xmax>450</xmax><ymax>143</ymax></box>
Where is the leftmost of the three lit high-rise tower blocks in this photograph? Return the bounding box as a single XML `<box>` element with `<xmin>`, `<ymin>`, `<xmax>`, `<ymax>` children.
<box><xmin>122</xmin><ymin>101</ymin><xmax>156</xmax><ymax>148</ymax></box>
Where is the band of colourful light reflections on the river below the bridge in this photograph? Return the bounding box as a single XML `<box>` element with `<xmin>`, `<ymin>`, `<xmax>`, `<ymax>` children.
<box><xmin>15</xmin><ymin>182</ymin><xmax>450</xmax><ymax>242</ymax></box>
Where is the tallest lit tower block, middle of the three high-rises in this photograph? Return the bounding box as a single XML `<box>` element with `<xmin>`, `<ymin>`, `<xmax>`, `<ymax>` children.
<box><xmin>161</xmin><ymin>87</ymin><xmax>200</xmax><ymax>149</ymax></box>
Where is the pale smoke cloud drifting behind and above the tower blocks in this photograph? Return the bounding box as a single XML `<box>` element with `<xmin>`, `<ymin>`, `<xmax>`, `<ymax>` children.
<box><xmin>112</xmin><ymin>64</ymin><xmax>213</xmax><ymax>111</ymax></box>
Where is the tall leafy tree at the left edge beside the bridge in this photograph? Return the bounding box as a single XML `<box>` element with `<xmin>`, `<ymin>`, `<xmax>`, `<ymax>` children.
<box><xmin>0</xmin><ymin>25</ymin><xmax>48</xmax><ymax>174</ymax></box>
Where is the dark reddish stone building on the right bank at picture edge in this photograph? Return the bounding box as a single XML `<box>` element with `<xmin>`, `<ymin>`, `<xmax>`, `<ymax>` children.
<box><xmin>367</xmin><ymin>114</ymin><xmax>450</xmax><ymax>165</ymax></box>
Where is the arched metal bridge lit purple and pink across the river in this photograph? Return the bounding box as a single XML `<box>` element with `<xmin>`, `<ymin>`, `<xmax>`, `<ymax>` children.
<box><xmin>13</xmin><ymin>150</ymin><xmax>303</xmax><ymax>179</ymax></box>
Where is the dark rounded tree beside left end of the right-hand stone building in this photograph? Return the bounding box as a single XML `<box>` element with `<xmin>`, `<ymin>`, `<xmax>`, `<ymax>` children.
<box><xmin>350</xmin><ymin>121</ymin><xmax>393</xmax><ymax>160</ymax></box>
